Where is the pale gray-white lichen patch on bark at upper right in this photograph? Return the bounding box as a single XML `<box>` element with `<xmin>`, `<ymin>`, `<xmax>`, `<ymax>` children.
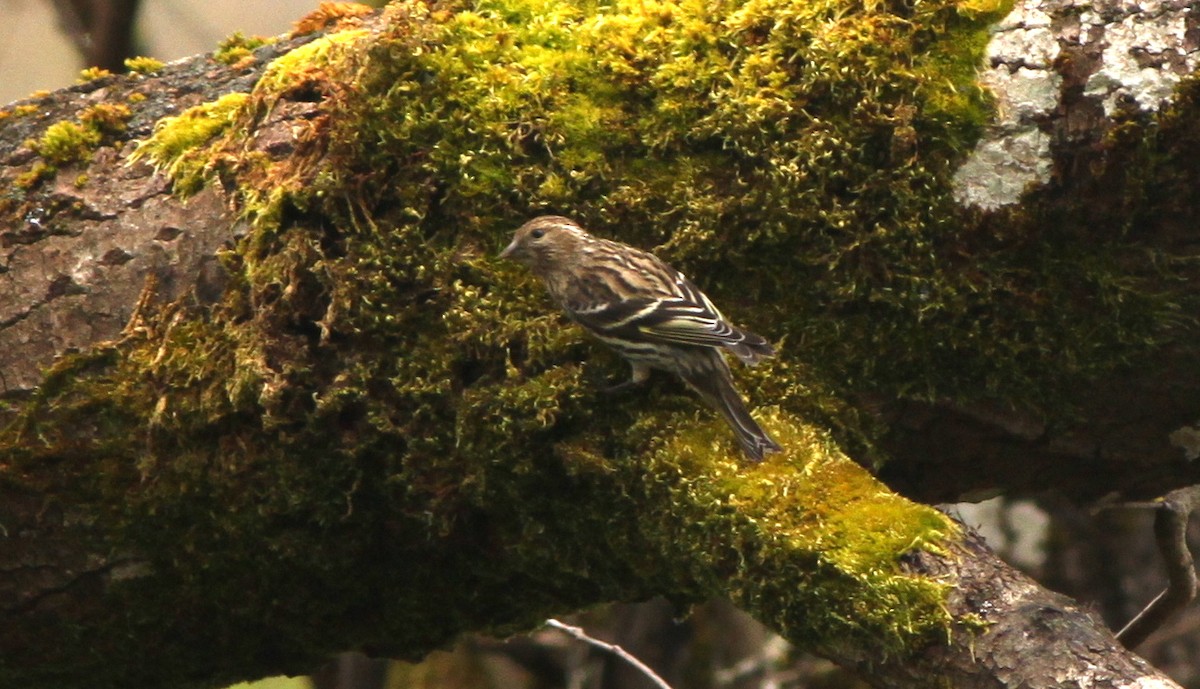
<box><xmin>955</xmin><ymin>0</ymin><xmax>1200</xmax><ymax>209</ymax></box>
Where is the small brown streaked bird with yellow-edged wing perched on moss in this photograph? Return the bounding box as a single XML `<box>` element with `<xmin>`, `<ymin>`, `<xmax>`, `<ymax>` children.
<box><xmin>500</xmin><ymin>215</ymin><xmax>782</xmax><ymax>462</ymax></box>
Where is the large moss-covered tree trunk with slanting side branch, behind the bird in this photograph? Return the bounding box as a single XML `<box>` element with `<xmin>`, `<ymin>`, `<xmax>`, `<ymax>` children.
<box><xmin>0</xmin><ymin>2</ymin><xmax>1200</xmax><ymax>689</ymax></box>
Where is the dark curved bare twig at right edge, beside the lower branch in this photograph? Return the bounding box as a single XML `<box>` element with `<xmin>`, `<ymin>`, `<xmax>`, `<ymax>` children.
<box><xmin>1117</xmin><ymin>486</ymin><xmax>1200</xmax><ymax>649</ymax></box>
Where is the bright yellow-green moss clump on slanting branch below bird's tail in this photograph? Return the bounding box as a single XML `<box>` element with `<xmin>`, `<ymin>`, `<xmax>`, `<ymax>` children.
<box><xmin>654</xmin><ymin>417</ymin><xmax>958</xmax><ymax>655</ymax></box>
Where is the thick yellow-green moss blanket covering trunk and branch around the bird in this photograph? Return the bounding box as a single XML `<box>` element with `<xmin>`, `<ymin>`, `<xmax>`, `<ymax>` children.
<box><xmin>0</xmin><ymin>0</ymin><xmax>1200</xmax><ymax>681</ymax></box>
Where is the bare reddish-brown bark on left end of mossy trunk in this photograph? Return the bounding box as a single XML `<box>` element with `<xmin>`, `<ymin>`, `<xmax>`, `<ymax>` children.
<box><xmin>0</xmin><ymin>32</ymin><xmax>316</xmax><ymax>397</ymax></box>
